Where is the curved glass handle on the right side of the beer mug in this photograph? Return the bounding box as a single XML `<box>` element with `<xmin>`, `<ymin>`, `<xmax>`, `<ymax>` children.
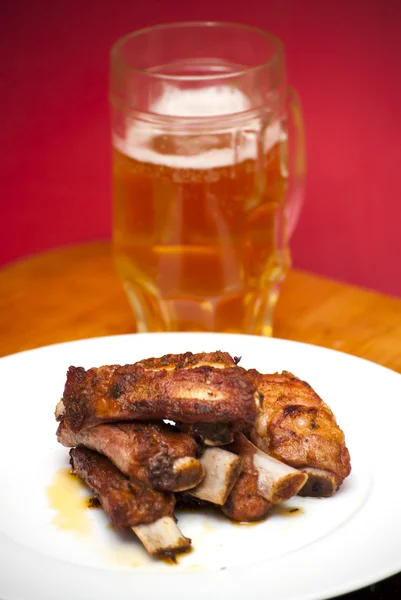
<box><xmin>286</xmin><ymin>86</ymin><xmax>306</xmax><ymax>238</ymax></box>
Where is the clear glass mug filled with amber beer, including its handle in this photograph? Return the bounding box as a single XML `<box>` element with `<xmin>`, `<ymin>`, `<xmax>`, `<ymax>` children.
<box><xmin>110</xmin><ymin>22</ymin><xmax>304</xmax><ymax>335</ymax></box>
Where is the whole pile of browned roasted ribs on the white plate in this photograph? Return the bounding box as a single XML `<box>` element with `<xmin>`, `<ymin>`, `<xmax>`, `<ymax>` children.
<box><xmin>56</xmin><ymin>351</ymin><xmax>351</xmax><ymax>556</ymax></box>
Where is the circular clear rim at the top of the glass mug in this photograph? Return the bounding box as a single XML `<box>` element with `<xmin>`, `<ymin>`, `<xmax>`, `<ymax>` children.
<box><xmin>110</xmin><ymin>20</ymin><xmax>284</xmax><ymax>81</ymax></box>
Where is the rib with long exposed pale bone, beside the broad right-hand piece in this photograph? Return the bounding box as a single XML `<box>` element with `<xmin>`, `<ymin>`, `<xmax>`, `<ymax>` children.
<box><xmin>222</xmin><ymin>434</ymin><xmax>307</xmax><ymax>521</ymax></box>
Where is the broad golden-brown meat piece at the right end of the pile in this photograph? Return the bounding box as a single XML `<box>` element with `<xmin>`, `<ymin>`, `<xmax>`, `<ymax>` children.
<box><xmin>248</xmin><ymin>370</ymin><xmax>351</xmax><ymax>496</ymax></box>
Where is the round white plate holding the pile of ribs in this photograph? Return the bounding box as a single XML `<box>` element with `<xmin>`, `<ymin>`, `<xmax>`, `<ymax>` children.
<box><xmin>0</xmin><ymin>333</ymin><xmax>401</xmax><ymax>600</ymax></box>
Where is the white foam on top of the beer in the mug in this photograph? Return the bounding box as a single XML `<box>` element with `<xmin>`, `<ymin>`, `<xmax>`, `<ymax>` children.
<box><xmin>113</xmin><ymin>85</ymin><xmax>286</xmax><ymax>170</ymax></box>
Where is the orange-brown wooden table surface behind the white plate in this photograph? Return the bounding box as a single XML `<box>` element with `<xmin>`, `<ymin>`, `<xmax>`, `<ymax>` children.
<box><xmin>0</xmin><ymin>243</ymin><xmax>401</xmax><ymax>600</ymax></box>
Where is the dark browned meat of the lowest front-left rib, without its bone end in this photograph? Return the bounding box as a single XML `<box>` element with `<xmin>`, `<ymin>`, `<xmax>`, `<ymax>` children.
<box><xmin>70</xmin><ymin>446</ymin><xmax>175</xmax><ymax>529</ymax></box>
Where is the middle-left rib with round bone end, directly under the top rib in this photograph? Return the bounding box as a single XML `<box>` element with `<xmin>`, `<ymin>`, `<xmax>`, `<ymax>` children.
<box><xmin>57</xmin><ymin>421</ymin><xmax>204</xmax><ymax>491</ymax></box>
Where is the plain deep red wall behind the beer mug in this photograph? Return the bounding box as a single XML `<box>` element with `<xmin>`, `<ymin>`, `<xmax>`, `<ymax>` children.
<box><xmin>0</xmin><ymin>0</ymin><xmax>401</xmax><ymax>296</ymax></box>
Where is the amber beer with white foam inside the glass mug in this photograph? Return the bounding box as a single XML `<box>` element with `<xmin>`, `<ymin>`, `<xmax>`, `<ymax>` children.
<box><xmin>113</xmin><ymin>89</ymin><xmax>289</xmax><ymax>335</ymax></box>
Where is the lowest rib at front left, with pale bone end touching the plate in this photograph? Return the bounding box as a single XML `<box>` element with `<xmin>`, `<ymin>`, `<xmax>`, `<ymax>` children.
<box><xmin>70</xmin><ymin>447</ymin><xmax>191</xmax><ymax>556</ymax></box>
